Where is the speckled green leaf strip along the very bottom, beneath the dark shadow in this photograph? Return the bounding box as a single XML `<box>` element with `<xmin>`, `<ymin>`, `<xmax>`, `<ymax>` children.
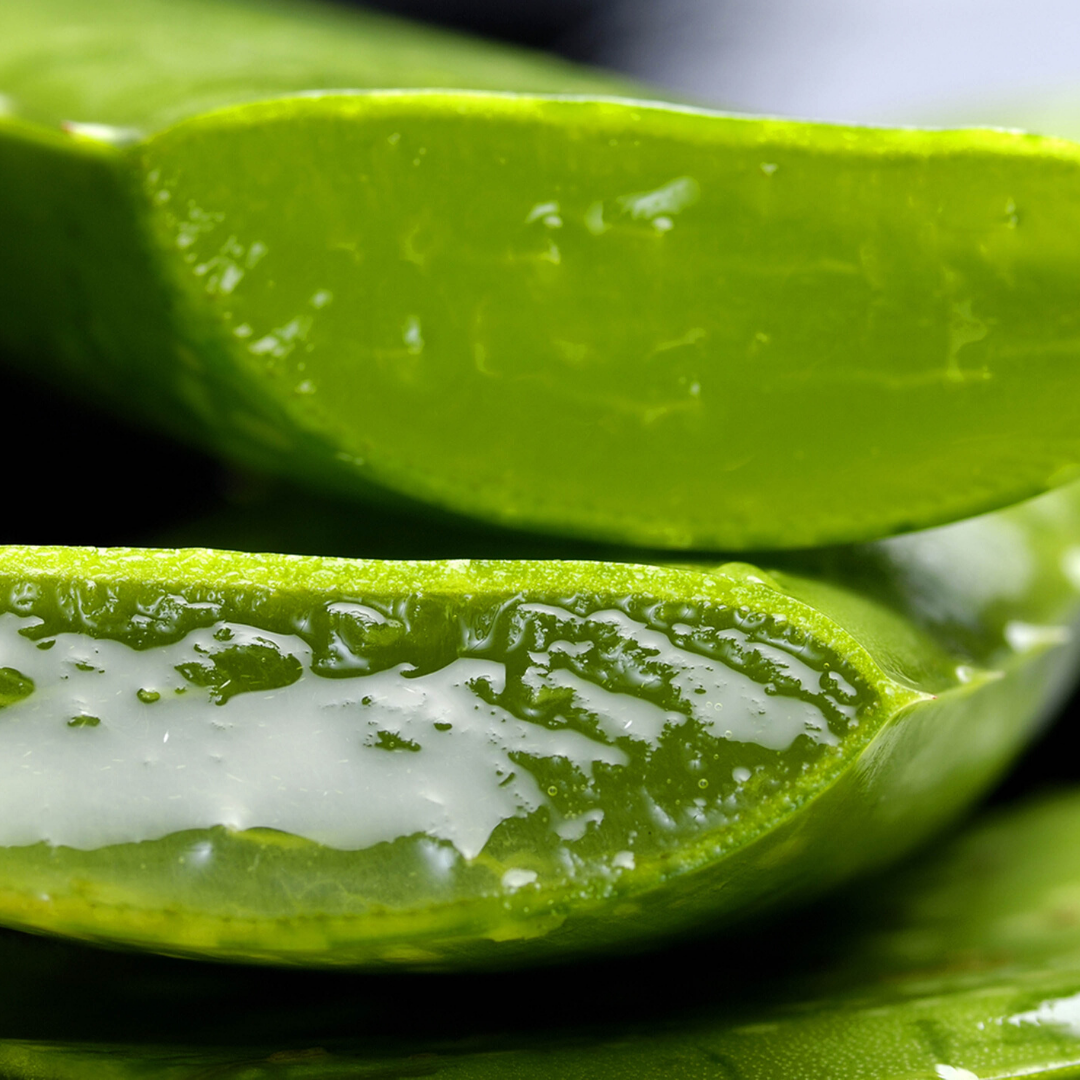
<box><xmin>6</xmin><ymin>971</ymin><xmax>1080</xmax><ymax>1080</ymax></box>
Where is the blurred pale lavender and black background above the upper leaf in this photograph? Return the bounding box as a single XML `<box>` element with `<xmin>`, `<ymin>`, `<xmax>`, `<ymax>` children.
<box><xmin>358</xmin><ymin>0</ymin><xmax>1080</xmax><ymax>134</ymax></box>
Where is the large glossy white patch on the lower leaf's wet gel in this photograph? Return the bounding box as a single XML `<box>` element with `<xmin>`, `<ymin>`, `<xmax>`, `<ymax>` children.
<box><xmin>0</xmin><ymin>615</ymin><xmax>625</xmax><ymax>859</ymax></box>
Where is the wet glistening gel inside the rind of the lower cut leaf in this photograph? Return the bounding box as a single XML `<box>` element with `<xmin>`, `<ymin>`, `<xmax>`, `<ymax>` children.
<box><xmin>0</xmin><ymin>597</ymin><xmax>870</xmax><ymax>868</ymax></box>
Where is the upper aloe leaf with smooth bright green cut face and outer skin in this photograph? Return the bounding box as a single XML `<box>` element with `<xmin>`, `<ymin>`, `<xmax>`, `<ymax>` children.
<box><xmin>6</xmin><ymin>0</ymin><xmax>1080</xmax><ymax>550</ymax></box>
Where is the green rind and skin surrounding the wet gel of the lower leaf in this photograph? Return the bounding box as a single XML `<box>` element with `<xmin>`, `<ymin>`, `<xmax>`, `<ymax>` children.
<box><xmin>3</xmin><ymin>490</ymin><xmax>1080</xmax><ymax>968</ymax></box>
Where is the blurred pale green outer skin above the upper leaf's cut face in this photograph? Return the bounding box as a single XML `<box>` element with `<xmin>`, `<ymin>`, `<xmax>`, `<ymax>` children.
<box><xmin>0</xmin><ymin>0</ymin><xmax>640</xmax><ymax>133</ymax></box>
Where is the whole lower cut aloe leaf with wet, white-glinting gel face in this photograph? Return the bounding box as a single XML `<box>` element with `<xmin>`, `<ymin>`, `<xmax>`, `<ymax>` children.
<box><xmin>0</xmin><ymin>489</ymin><xmax>1080</xmax><ymax>968</ymax></box>
